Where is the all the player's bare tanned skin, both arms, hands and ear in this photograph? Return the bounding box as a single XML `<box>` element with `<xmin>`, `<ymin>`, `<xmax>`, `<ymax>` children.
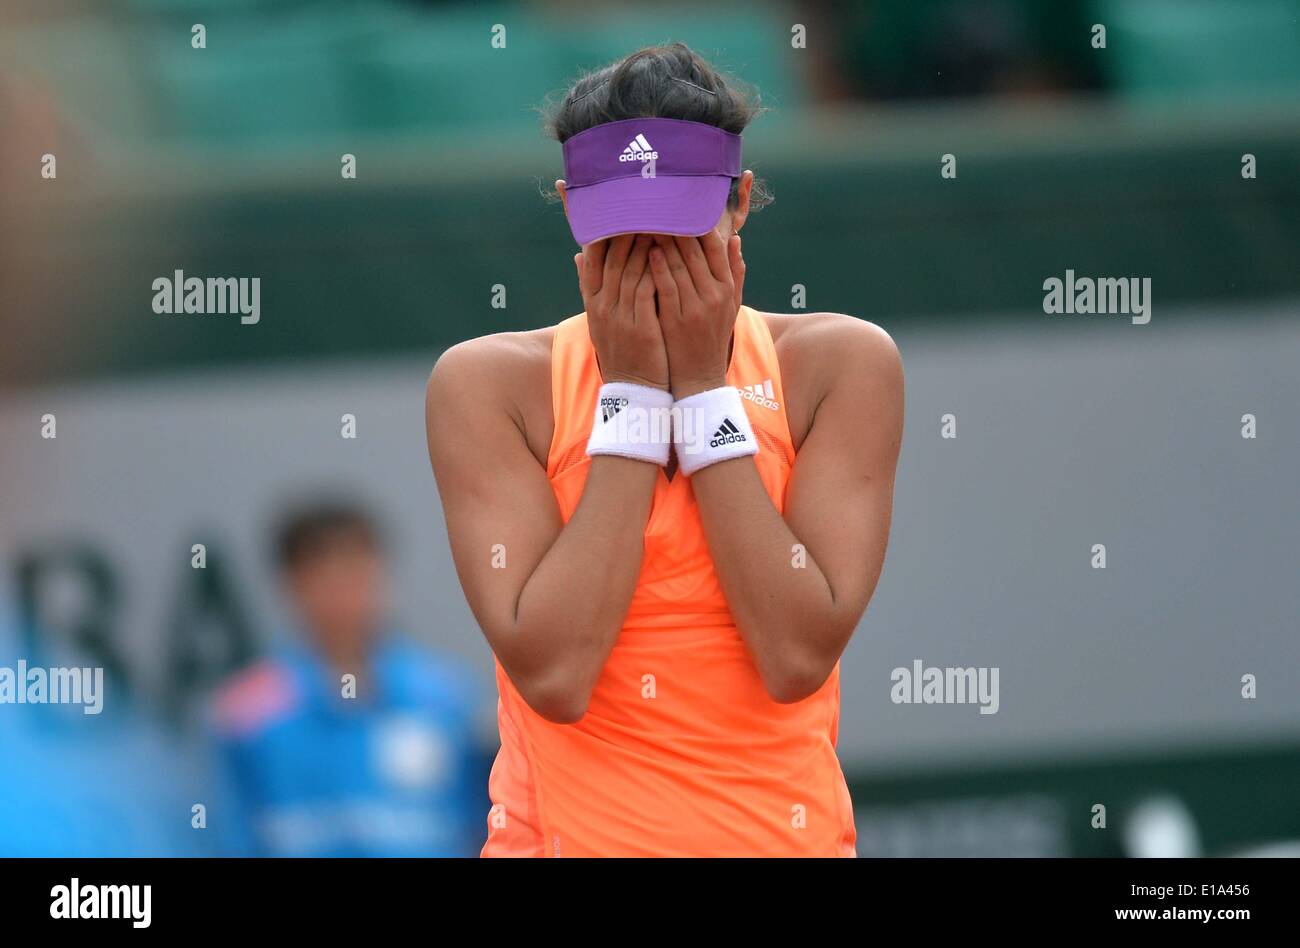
<box><xmin>426</xmin><ymin>172</ymin><xmax>904</xmax><ymax>723</ymax></box>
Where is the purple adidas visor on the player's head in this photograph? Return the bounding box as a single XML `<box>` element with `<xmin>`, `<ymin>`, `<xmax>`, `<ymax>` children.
<box><xmin>564</xmin><ymin>118</ymin><xmax>740</xmax><ymax>244</ymax></box>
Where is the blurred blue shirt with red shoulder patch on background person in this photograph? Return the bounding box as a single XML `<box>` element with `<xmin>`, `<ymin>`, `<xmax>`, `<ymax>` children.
<box><xmin>209</xmin><ymin>641</ymin><xmax>486</xmax><ymax>856</ymax></box>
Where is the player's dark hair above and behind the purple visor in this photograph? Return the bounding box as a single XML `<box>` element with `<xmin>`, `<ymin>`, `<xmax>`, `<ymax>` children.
<box><xmin>543</xmin><ymin>43</ymin><xmax>772</xmax><ymax>209</ymax></box>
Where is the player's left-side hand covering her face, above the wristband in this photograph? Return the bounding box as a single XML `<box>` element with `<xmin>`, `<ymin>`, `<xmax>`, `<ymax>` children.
<box><xmin>573</xmin><ymin>234</ymin><xmax>668</xmax><ymax>391</ymax></box>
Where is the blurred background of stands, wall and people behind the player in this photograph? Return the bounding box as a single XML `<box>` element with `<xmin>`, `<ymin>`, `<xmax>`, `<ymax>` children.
<box><xmin>0</xmin><ymin>0</ymin><xmax>1300</xmax><ymax>856</ymax></box>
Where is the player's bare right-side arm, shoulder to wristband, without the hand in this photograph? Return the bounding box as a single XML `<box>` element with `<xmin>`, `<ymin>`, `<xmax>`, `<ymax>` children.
<box><xmin>692</xmin><ymin>320</ymin><xmax>902</xmax><ymax>701</ymax></box>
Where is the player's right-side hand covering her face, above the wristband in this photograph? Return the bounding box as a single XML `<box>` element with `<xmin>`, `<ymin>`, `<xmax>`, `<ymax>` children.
<box><xmin>650</xmin><ymin>230</ymin><xmax>745</xmax><ymax>399</ymax></box>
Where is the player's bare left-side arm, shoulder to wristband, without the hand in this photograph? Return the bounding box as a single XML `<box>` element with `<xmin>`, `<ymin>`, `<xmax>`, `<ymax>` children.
<box><xmin>425</xmin><ymin>339</ymin><xmax>658</xmax><ymax>723</ymax></box>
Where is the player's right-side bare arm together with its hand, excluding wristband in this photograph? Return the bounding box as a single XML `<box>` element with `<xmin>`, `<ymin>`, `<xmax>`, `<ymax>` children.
<box><xmin>650</xmin><ymin>231</ymin><xmax>902</xmax><ymax>702</ymax></box>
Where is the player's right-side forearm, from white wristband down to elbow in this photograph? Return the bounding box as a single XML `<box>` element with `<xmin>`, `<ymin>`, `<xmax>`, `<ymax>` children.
<box><xmin>692</xmin><ymin>458</ymin><xmax>862</xmax><ymax>701</ymax></box>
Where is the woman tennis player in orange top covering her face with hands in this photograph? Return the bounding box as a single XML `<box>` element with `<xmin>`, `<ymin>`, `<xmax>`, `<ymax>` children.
<box><xmin>428</xmin><ymin>44</ymin><xmax>904</xmax><ymax>856</ymax></box>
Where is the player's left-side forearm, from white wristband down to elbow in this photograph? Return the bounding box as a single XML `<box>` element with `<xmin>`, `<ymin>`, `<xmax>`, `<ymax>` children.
<box><xmin>507</xmin><ymin>456</ymin><xmax>659</xmax><ymax>717</ymax></box>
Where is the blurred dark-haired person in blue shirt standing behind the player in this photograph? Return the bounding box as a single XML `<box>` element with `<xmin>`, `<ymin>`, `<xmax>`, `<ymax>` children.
<box><xmin>211</xmin><ymin>506</ymin><xmax>486</xmax><ymax>856</ymax></box>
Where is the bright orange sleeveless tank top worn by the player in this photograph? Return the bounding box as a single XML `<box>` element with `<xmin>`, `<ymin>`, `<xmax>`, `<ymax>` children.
<box><xmin>482</xmin><ymin>307</ymin><xmax>855</xmax><ymax>856</ymax></box>
